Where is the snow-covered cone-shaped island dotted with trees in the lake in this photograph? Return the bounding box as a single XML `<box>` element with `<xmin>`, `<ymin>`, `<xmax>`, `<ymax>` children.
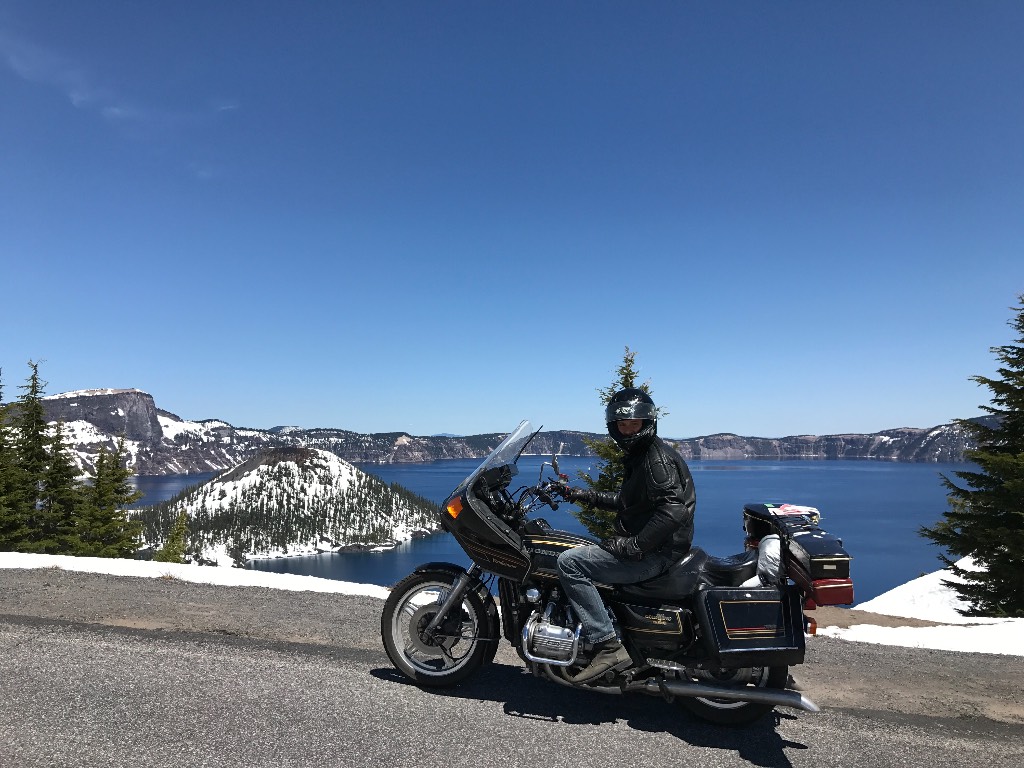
<box><xmin>139</xmin><ymin>446</ymin><xmax>439</xmax><ymax>565</ymax></box>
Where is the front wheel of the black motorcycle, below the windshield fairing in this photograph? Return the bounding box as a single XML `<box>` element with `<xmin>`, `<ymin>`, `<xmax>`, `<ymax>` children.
<box><xmin>381</xmin><ymin>571</ymin><xmax>498</xmax><ymax>687</ymax></box>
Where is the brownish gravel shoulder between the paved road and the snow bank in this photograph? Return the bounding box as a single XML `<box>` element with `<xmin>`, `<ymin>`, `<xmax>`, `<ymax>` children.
<box><xmin>0</xmin><ymin>568</ymin><xmax>1024</xmax><ymax>726</ymax></box>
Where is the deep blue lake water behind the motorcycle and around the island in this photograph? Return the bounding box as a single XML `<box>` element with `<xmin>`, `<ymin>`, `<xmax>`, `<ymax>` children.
<box><xmin>139</xmin><ymin>457</ymin><xmax>971</xmax><ymax>602</ymax></box>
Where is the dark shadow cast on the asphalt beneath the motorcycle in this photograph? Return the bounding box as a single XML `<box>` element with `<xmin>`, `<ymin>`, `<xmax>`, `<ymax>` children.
<box><xmin>370</xmin><ymin>663</ymin><xmax>809</xmax><ymax>768</ymax></box>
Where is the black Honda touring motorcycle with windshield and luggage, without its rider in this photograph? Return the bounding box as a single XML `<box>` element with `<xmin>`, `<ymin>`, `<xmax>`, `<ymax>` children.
<box><xmin>381</xmin><ymin>421</ymin><xmax>853</xmax><ymax>724</ymax></box>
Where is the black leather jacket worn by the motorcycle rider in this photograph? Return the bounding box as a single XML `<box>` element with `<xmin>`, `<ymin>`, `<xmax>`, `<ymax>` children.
<box><xmin>588</xmin><ymin>435</ymin><xmax>696</xmax><ymax>559</ymax></box>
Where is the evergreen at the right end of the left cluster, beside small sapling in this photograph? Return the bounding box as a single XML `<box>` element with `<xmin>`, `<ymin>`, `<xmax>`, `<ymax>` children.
<box><xmin>76</xmin><ymin>437</ymin><xmax>142</xmax><ymax>557</ymax></box>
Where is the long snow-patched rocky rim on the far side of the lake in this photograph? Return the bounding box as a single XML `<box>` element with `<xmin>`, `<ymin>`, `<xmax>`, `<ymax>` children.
<box><xmin>36</xmin><ymin>389</ymin><xmax>973</xmax><ymax>475</ymax></box>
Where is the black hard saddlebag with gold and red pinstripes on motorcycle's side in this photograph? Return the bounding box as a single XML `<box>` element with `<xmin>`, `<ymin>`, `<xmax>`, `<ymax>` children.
<box><xmin>693</xmin><ymin>587</ymin><xmax>804</xmax><ymax>669</ymax></box>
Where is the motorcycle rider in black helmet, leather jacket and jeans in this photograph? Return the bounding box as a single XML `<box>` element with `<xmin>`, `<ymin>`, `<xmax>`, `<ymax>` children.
<box><xmin>558</xmin><ymin>387</ymin><xmax>696</xmax><ymax>683</ymax></box>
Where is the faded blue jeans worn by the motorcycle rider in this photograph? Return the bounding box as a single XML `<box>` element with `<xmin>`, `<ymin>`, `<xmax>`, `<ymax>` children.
<box><xmin>558</xmin><ymin>545</ymin><xmax>672</xmax><ymax>644</ymax></box>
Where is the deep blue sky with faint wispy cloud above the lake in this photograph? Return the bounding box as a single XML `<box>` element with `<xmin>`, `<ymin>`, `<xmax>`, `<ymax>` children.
<box><xmin>0</xmin><ymin>0</ymin><xmax>1024</xmax><ymax>437</ymax></box>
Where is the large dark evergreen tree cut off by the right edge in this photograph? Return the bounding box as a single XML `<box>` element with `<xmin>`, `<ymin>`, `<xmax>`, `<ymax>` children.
<box><xmin>921</xmin><ymin>294</ymin><xmax>1024</xmax><ymax>617</ymax></box>
